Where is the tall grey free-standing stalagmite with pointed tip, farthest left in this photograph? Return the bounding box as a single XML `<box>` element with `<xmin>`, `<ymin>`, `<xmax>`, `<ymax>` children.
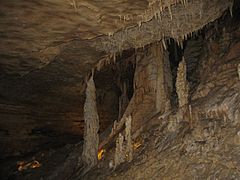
<box><xmin>82</xmin><ymin>75</ymin><xmax>99</xmax><ymax>168</ymax></box>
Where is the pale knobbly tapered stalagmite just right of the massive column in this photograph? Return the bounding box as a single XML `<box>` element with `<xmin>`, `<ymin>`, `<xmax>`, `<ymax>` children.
<box><xmin>176</xmin><ymin>57</ymin><xmax>189</xmax><ymax>108</ymax></box>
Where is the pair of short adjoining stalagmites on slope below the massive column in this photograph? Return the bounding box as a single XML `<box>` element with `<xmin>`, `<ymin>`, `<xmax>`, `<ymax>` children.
<box><xmin>114</xmin><ymin>116</ymin><xmax>133</xmax><ymax>168</ymax></box>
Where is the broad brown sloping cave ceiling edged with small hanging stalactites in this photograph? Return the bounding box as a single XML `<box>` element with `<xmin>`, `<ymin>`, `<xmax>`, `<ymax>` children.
<box><xmin>0</xmin><ymin>0</ymin><xmax>232</xmax><ymax>107</ymax></box>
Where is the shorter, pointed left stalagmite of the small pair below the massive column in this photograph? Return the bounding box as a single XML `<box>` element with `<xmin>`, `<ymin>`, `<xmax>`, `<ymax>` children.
<box><xmin>114</xmin><ymin>133</ymin><xmax>125</xmax><ymax>169</ymax></box>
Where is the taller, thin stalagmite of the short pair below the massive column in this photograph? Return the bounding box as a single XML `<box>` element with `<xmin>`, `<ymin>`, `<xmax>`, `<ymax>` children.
<box><xmin>125</xmin><ymin>116</ymin><xmax>133</xmax><ymax>162</ymax></box>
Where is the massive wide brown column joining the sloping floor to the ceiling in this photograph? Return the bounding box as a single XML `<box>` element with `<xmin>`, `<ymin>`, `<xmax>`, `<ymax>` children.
<box><xmin>124</xmin><ymin>43</ymin><xmax>172</xmax><ymax>132</ymax></box>
